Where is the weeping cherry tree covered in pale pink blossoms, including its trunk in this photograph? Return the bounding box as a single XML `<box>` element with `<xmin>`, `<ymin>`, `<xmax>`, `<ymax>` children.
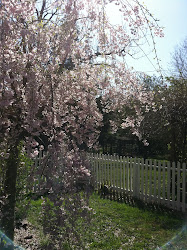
<box><xmin>0</xmin><ymin>0</ymin><xmax>163</xmax><ymax>243</ymax></box>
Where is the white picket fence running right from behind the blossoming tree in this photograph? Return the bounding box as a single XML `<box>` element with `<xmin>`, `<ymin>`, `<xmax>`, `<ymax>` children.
<box><xmin>89</xmin><ymin>154</ymin><xmax>187</xmax><ymax>212</ymax></box>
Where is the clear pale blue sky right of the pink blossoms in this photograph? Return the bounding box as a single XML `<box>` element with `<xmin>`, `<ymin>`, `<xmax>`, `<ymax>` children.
<box><xmin>127</xmin><ymin>0</ymin><xmax>187</xmax><ymax>75</ymax></box>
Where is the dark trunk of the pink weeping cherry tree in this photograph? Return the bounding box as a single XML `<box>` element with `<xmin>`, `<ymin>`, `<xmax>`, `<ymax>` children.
<box><xmin>1</xmin><ymin>145</ymin><xmax>19</xmax><ymax>240</ymax></box>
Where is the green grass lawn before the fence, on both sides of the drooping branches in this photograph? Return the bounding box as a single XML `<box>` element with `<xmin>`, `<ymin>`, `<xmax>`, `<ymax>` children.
<box><xmin>17</xmin><ymin>193</ymin><xmax>187</xmax><ymax>250</ymax></box>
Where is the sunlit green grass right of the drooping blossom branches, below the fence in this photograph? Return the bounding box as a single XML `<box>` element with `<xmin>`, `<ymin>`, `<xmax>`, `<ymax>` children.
<box><xmin>90</xmin><ymin>196</ymin><xmax>187</xmax><ymax>249</ymax></box>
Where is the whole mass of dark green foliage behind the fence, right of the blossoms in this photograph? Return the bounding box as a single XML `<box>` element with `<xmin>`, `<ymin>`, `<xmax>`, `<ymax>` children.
<box><xmin>98</xmin><ymin>76</ymin><xmax>187</xmax><ymax>162</ymax></box>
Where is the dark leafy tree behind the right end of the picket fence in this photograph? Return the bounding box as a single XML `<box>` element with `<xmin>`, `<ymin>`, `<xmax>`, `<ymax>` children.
<box><xmin>121</xmin><ymin>74</ymin><xmax>187</xmax><ymax>162</ymax></box>
